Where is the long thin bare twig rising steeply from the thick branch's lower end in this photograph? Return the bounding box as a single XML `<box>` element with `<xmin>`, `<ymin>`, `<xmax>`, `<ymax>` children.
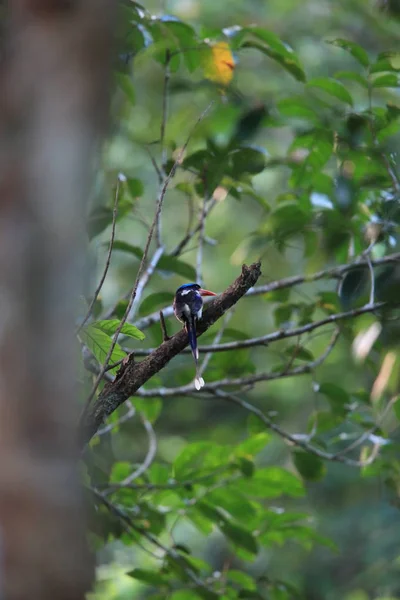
<box><xmin>81</xmin><ymin>103</ymin><xmax>212</xmax><ymax>420</ymax></box>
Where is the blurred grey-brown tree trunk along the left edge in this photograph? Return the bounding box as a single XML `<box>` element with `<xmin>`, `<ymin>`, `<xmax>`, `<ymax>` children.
<box><xmin>0</xmin><ymin>0</ymin><xmax>115</xmax><ymax>600</ymax></box>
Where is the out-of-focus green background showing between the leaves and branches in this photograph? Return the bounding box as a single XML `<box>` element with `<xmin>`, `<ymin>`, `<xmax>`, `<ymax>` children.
<box><xmin>88</xmin><ymin>0</ymin><xmax>400</xmax><ymax>600</ymax></box>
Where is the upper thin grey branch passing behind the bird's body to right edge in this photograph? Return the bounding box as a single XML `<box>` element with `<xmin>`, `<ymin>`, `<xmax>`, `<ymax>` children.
<box><xmin>134</xmin><ymin>251</ymin><xmax>400</xmax><ymax>330</ymax></box>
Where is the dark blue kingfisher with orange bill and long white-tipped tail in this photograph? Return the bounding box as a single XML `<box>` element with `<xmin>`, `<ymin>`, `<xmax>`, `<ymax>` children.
<box><xmin>173</xmin><ymin>283</ymin><xmax>217</xmax><ymax>390</ymax></box>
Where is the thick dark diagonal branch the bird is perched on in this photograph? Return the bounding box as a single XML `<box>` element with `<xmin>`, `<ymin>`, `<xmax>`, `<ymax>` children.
<box><xmin>80</xmin><ymin>263</ymin><xmax>261</xmax><ymax>443</ymax></box>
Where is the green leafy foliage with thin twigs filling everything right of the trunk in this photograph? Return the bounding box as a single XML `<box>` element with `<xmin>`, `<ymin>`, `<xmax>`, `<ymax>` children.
<box><xmin>78</xmin><ymin>0</ymin><xmax>400</xmax><ymax>600</ymax></box>
